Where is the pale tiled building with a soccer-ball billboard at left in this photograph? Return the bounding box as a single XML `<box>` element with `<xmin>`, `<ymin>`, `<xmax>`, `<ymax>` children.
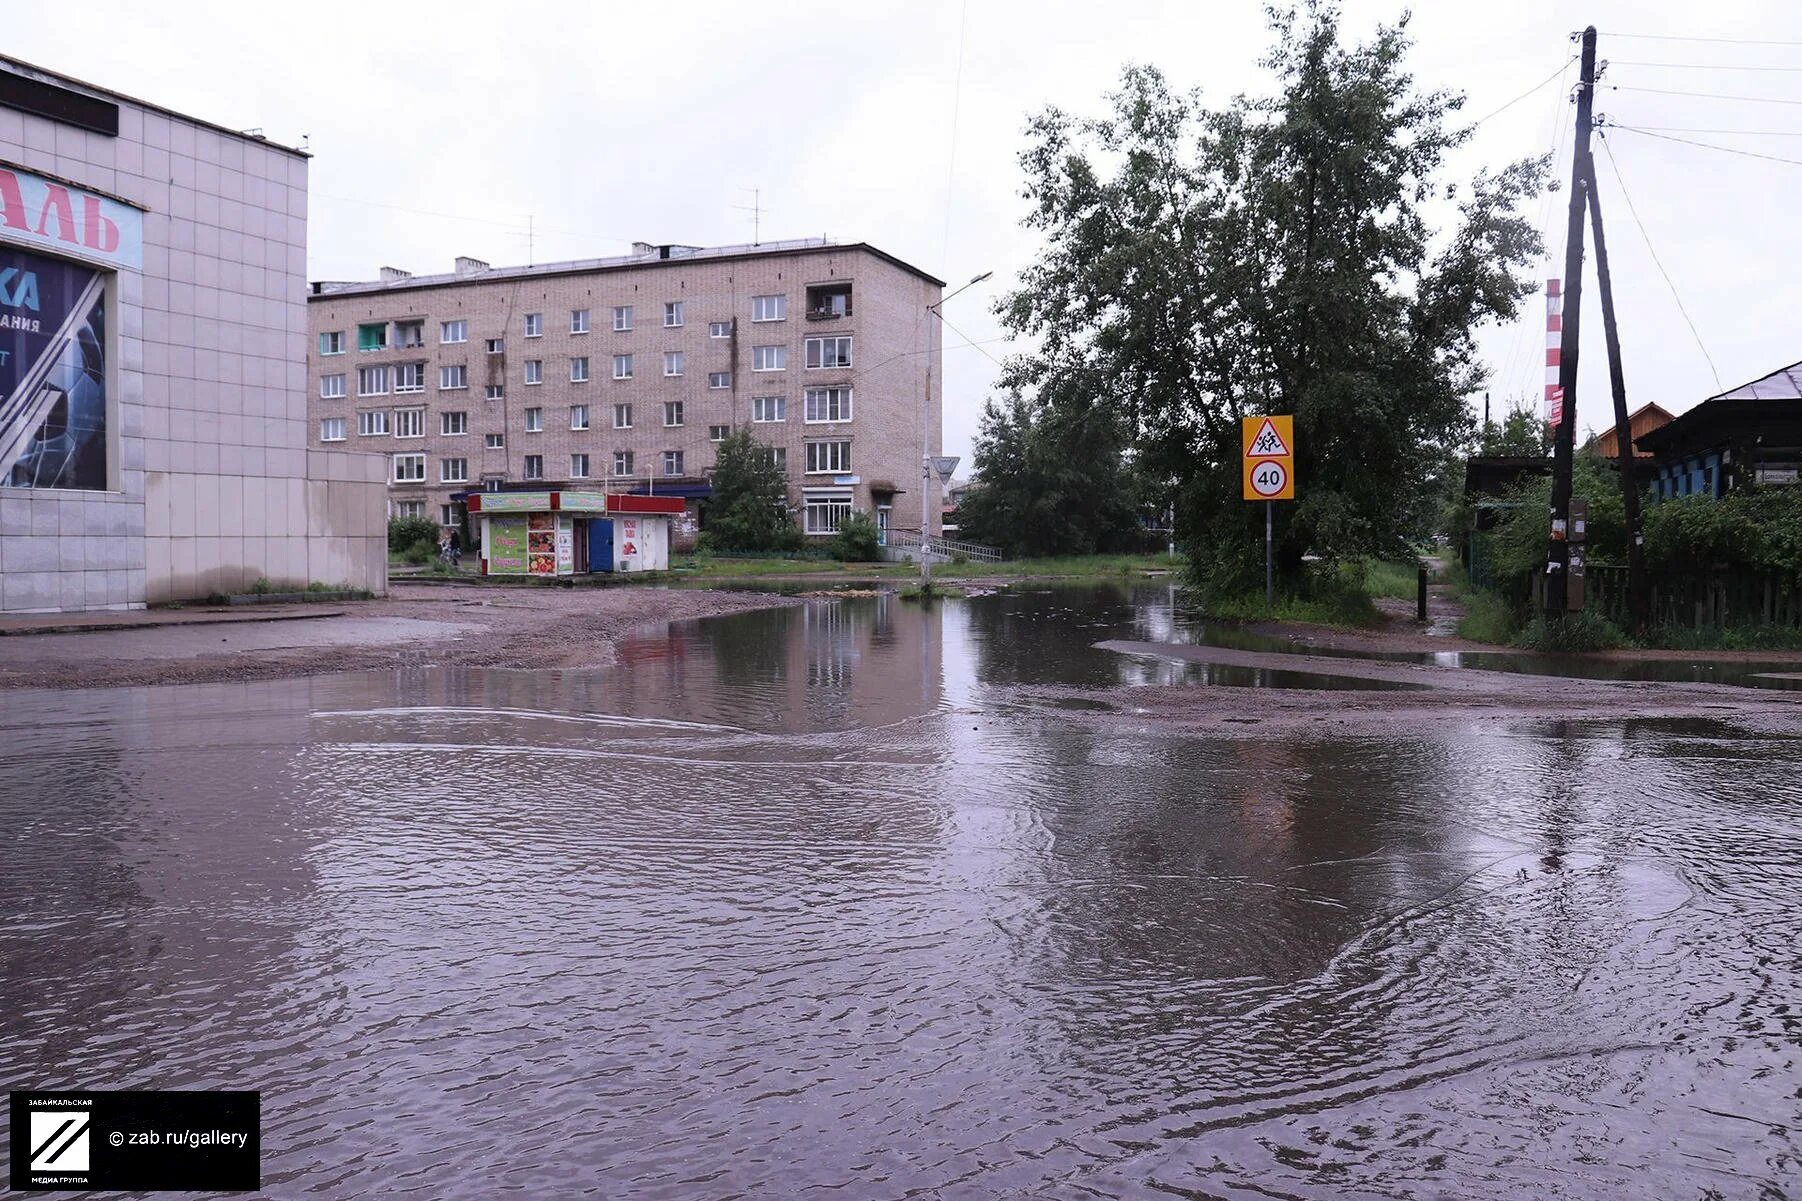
<box><xmin>0</xmin><ymin>56</ymin><xmax>387</xmax><ymax>611</ymax></box>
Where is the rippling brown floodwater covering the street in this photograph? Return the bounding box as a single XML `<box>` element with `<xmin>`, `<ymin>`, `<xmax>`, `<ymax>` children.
<box><xmin>0</xmin><ymin>586</ymin><xmax>1802</xmax><ymax>1199</ymax></box>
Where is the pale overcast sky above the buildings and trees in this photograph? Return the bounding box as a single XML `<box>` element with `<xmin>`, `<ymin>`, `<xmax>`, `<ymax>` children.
<box><xmin>5</xmin><ymin>0</ymin><xmax>1802</xmax><ymax>465</ymax></box>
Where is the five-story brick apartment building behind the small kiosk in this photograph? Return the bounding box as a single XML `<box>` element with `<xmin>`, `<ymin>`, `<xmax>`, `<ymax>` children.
<box><xmin>308</xmin><ymin>240</ymin><xmax>944</xmax><ymax>536</ymax></box>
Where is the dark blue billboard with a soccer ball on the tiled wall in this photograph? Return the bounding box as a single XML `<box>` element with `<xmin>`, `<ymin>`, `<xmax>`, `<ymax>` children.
<box><xmin>0</xmin><ymin>245</ymin><xmax>106</xmax><ymax>490</ymax></box>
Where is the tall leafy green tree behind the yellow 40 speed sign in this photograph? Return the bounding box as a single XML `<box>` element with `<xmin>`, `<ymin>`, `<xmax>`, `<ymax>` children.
<box><xmin>1000</xmin><ymin>4</ymin><xmax>1546</xmax><ymax>586</ymax></box>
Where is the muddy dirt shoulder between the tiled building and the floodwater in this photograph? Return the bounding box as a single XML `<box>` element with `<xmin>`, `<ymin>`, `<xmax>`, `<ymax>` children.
<box><xmin>0</xmin><ymin>582</ymin><xmax>804</xmax><ymax>689</ymax></box>
